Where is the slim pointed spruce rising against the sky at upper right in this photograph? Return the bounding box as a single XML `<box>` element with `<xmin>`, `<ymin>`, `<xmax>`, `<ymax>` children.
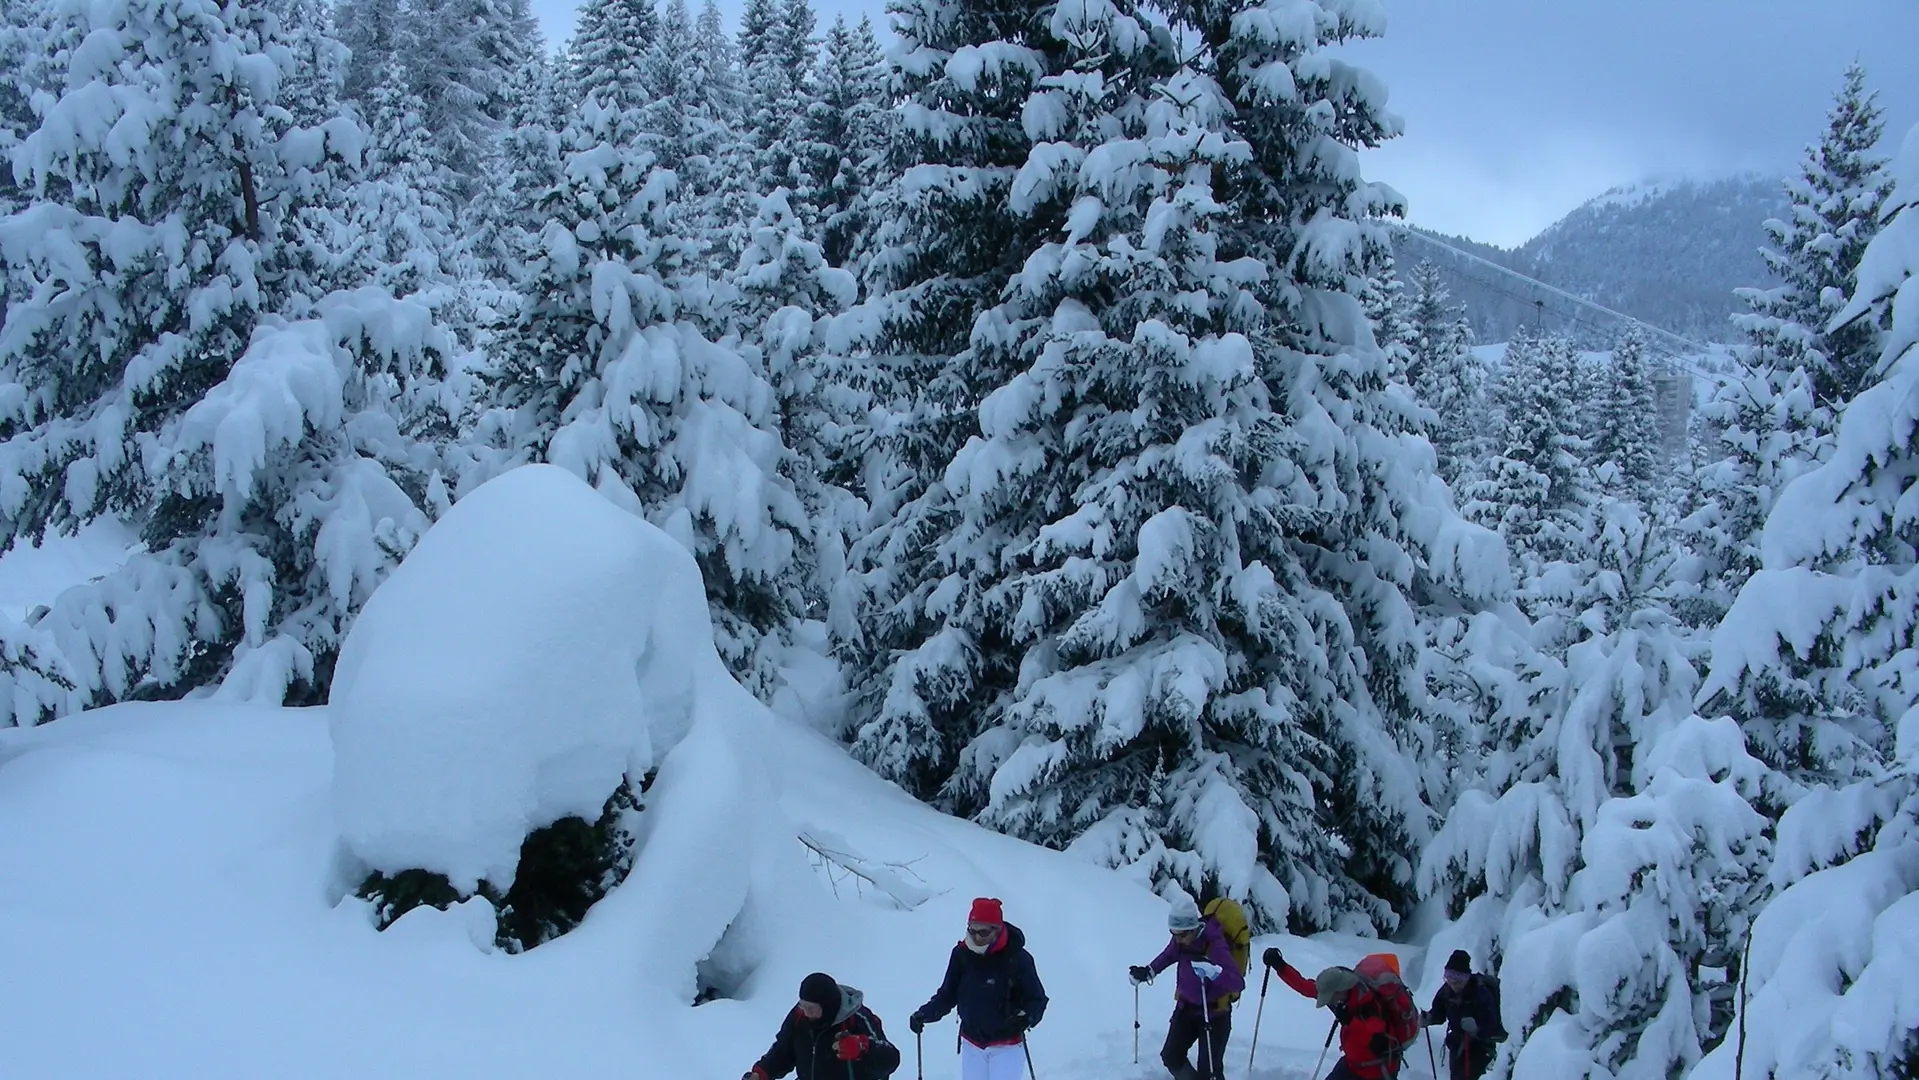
<box><xmin>1735</xmin><ymin>63</ymin><xmax>1890</xmax><ymax>412</ymax></box>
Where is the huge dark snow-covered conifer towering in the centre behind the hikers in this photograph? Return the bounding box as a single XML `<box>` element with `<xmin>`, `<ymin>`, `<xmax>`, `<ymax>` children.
<box><xmin>842</xmin><ymin>0</ymin><xmax>1504</xmax><ymax>927</ymax></box>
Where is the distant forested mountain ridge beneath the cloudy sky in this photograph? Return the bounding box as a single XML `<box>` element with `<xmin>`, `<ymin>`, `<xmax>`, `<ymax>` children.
<box><xmin>1395</xmin><ymin>175</ymin><xmax>1787</xmax><ymax>347</ymax></box>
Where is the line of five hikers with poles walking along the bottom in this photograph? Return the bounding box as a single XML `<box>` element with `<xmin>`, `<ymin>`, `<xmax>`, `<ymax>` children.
<box><xmin>741</xmin><ymin>896</ymin><xmax>1506</xmax><ymax>1080</ymax></box>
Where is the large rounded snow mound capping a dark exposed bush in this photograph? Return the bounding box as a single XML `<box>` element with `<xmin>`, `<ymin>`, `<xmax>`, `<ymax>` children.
<box><xmin>328</xmin><ymin>466</ymin><xmax>720</xmax><ymax>892</ymax></box>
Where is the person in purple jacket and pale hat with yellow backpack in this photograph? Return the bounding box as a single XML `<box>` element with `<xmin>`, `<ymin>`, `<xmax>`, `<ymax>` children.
<box><xmin>1130</xmin><ymin>894</ymin><xmax>1245</xmax><ymax>1080</ymax></box>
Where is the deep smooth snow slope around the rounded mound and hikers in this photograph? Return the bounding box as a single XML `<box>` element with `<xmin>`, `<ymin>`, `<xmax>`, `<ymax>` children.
<box><xmin>0</xmin><ymin>693</ymin><xmax>1424</xmax><ymax>1080</ymax></box>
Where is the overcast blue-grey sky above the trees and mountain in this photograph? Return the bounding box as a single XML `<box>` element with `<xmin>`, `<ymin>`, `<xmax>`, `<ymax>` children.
<box><xmin>533</xmin><ymin>0</ymin><xmax>1919</xmax><ymax>246</ymax></box>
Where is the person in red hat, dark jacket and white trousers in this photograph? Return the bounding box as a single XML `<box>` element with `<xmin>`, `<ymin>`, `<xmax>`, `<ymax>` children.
<box><xmin>910</xmin><ymin>896</ymin><xmax>1046</xmax><ymax>1080</ymax></box>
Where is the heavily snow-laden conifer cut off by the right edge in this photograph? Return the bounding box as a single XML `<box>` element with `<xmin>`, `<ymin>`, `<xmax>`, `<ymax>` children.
<box><xmin>1694</xmin><ymin>118</ymin><xmax>1919</xmax><ymax>1080</ymax></box>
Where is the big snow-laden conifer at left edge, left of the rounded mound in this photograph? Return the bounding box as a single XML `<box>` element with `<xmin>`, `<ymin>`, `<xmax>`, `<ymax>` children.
<box><xmin>0</xmin><ymin>0</ymin><xmax>460</xmax><ymax>721</ymax></box>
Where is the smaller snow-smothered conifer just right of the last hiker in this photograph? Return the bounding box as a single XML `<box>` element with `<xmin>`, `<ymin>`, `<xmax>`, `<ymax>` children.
<box><xmin>1420</xmin><ymin>499</ymin><xmax>1769</xmax><ymax>1080</ymax></box>
